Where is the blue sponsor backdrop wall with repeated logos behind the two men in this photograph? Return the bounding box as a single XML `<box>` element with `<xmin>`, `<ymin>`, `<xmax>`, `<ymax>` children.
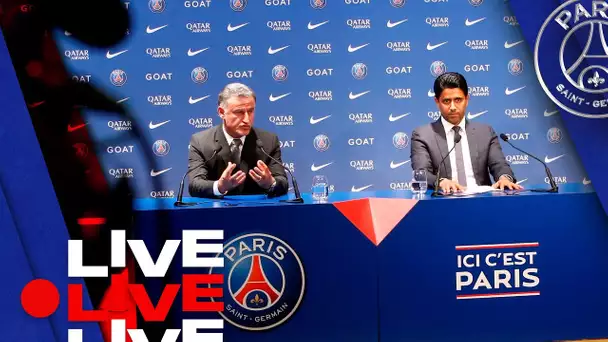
<box><xmin>57</xmin><ymin>0</ymin><xmax>588</xmax><ymax>197</ymax></box>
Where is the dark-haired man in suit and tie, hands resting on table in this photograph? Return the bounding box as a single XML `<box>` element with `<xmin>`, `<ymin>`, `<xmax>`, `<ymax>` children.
<box><xmin>411</xmin><ymin>72</ymin><xmax>522</xmax><ymax>192</ymax></box>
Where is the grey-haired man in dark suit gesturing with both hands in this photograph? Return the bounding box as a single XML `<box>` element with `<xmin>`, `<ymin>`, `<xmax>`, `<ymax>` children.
<box><xmin>188</xmin><ymin>83</ymin><xmax>288</xmax><ymax>198</ymax></box>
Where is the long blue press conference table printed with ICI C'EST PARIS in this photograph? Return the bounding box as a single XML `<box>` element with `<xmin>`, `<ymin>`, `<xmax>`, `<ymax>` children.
<box><xmin>135</xmin><ymin>184</ymin><xmax>608</xmax><ymax>342</ymax></box>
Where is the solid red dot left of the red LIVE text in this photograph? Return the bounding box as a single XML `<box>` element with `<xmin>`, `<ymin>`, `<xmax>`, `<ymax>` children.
<box><xmin>21</xmin><ymin>279</ymin><xmax>59</xmax><ymax>318</ymax></box>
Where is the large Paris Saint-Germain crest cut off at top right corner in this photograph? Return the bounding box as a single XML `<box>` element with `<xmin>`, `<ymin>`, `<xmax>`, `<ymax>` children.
<box><xmin>534</xmin><ymin>0</ymin><xmax>608</xmax><ymax>118</ymax></box>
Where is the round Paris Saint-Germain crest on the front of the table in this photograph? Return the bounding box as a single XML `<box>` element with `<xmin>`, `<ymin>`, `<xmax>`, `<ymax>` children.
<box><xmin>210</xmin><ymin>233</ymin><xmax>305</xmax><ymax>330</ymax></box>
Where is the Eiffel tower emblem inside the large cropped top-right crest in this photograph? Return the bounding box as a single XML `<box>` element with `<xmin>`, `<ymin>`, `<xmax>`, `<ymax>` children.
<box><xmin>560</xmin><ymin>21</ymin><xmax>608</xmax><ymax>93</ymax></box>
